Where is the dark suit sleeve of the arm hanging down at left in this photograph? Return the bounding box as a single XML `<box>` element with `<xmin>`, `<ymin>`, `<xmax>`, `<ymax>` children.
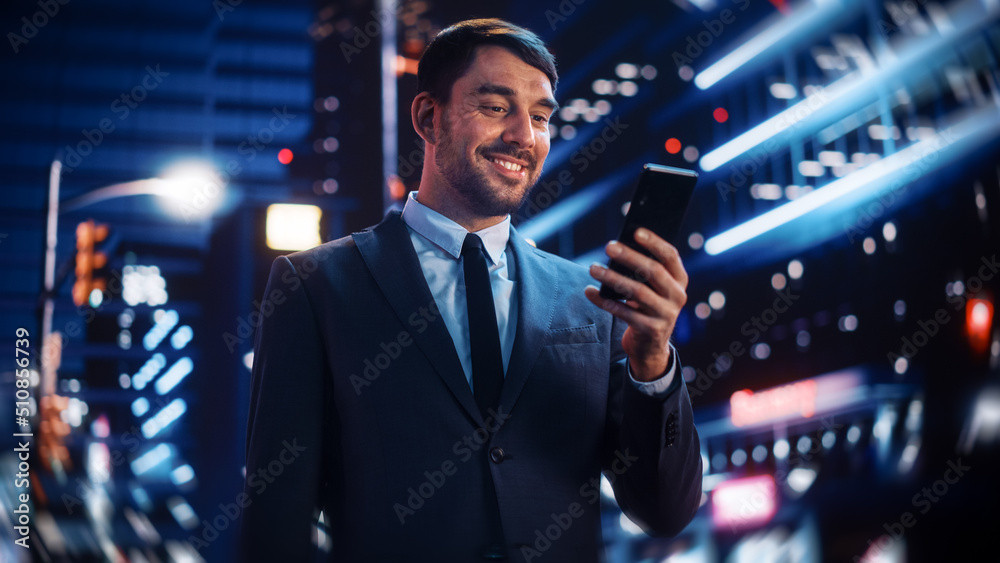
<box><xmin>239</xmin><ymin>256</ymin><xmax>337</xmax><ymax>561</ymax></box>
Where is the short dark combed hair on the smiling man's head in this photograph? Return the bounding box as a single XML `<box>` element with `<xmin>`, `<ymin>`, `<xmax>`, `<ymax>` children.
<box><xmin>417</xmin><ymin>18</ymin><xmax>559</xmax><ymax>104</ymax></box>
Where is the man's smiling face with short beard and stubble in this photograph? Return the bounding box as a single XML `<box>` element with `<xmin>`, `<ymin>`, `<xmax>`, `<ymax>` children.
<box><xmin>434</xmin><ymin>46</ymin><xmax>556</xmax><ymax>217</ymax></box>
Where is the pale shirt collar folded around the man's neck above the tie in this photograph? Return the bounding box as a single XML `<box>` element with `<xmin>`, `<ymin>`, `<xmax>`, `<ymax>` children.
<box><xmin>403</xmin><ymin>192</ymin><xmax>510</xmax><ymax>264</ymax></box>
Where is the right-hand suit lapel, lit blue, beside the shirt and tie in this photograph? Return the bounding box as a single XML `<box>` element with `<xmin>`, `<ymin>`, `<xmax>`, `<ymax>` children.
<box><xmin>500</xmin><ymin>228</ymin><xmax>562</xmax><ymax>412</ymax></box>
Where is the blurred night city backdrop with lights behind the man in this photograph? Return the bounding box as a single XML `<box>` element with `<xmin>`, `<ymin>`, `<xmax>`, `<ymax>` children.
<box><xmin>0</xmin><ymin>0</ymin><xmax>1000</xmax><ymax>563</ymax></box>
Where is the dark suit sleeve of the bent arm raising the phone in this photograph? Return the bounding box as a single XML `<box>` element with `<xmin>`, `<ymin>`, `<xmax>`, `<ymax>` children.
<box><xmin>604</xmin><ymin>319</ymin><xmax>702</xmax><ymax>536</ymax></box>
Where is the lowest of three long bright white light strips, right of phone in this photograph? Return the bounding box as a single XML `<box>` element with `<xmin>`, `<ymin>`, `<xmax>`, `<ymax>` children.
<box><xmin>705</xmin><ymin>108</ymin><xmax>1000</xmax><ymax>256</ymax></box>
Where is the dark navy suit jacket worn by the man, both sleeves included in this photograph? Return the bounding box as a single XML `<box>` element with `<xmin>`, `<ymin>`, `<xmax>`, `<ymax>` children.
<box><xmin>241</xmin><ymin>213</ymin><xmax>702</xmax><ymax>563</ymax></box>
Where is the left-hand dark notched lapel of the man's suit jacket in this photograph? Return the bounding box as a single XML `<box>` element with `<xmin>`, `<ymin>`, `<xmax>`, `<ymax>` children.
<box><xmin>353</xmin><ymin>211</ymin><xmax>483</xmax><ymax>425</ymax></box>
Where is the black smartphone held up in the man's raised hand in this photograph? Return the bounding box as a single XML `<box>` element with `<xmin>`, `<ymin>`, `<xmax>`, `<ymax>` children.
<box><xmin>601</xmin><ymin>164</ymin><xmax>698</xmax><ymax>299</ymax></box>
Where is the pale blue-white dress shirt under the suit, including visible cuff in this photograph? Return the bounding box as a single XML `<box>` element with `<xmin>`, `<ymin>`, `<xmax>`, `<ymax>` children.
<box><xmin>402</xmin><ymin>192</ymin><xmax>677</xmax><ymax>395</ymax></box>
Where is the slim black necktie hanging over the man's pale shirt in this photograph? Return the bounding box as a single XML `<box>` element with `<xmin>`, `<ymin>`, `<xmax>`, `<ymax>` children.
<box><xmin>462</xmin><ymin>233</ymin><xmax>503</xmax><ymax>416</ymax></box>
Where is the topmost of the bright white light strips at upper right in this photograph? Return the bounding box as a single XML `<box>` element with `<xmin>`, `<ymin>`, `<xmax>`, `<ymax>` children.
<box><xmin>694</xmin><ymin>0</ymin><xmax>844</xmax><ymax>90</ymax></box>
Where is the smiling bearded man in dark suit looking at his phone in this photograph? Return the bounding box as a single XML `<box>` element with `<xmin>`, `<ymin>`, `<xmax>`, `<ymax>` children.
<box><xmin>241</xmin><ymin>20</ymin><xmax>702</xmax><ymax>563</ymax></box>
